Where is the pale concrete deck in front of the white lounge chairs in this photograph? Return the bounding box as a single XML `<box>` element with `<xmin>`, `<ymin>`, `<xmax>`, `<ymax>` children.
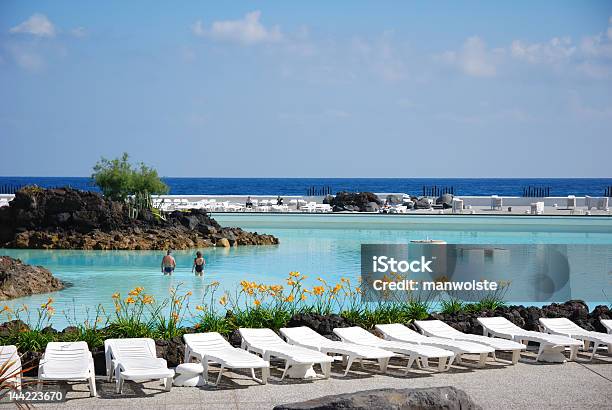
<box><xmin>13</xmin><ymin>352</ymin><xmax>612</xmax><ymax>410</ymax></box>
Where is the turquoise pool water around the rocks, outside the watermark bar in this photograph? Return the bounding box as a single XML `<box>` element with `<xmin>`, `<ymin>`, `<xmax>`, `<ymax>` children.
<box><xmin>0</xmin><ymin>215</ymin><xmax>612</xmax><ymax>328</ymax></box>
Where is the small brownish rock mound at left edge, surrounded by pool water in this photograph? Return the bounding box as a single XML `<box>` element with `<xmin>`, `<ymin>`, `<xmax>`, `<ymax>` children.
<box><xmin>0</xmin><ymin>256</ymin><xmax>64</xmax><ymax>300</ymax></box>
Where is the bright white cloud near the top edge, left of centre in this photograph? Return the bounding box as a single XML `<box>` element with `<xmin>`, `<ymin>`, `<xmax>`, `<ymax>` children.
<box><xmin>192</xmin><ymin>10</ymin><xmax>283</xmax><ymax>45</ymax></box>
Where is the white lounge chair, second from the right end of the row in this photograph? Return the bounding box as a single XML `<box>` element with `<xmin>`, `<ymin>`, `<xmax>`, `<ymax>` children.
<box><xmin>477</xmin><ymin>317</ymin><xmax>582</xmax><ymax>363</ymax></box>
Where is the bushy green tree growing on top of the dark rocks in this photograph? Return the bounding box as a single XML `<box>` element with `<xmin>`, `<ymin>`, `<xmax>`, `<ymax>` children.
<box><xmin>91</xmin><ymin>152</ymin><xmax>168</xmax><ymax>201</ymax></box>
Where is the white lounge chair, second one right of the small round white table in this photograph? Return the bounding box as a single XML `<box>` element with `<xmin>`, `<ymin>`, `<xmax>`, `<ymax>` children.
<box><xmin>238</xmin><ymin>328</ymin><xmax>334</xmax><ymax>380</ymax></box>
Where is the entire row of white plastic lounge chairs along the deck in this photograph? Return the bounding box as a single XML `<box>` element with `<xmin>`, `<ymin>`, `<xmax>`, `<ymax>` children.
<box><xmin>0</xmin><ymin>317</ymin><xmax>612</xmax><ymax>396</ymax></box>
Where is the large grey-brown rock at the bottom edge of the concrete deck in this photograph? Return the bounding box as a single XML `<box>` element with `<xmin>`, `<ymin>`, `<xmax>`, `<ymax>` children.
<box><xmin>274</xmin><ymin>386</ymin><xmax>481</xmax><ymax>410</ymax></box>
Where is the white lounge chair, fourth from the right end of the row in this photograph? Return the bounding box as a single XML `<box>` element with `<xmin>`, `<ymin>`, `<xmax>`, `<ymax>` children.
<box><xmin>376</xmin><ymin>323</ymin><xmax>495</xmax><ymax>367</ymax></box>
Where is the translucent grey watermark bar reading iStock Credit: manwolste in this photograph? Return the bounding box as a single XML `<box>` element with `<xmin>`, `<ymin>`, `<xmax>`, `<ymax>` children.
<box><xmin>361</xmin><ymin>243</ymin><xmax>612</xmax><ymax>303</ymax></box>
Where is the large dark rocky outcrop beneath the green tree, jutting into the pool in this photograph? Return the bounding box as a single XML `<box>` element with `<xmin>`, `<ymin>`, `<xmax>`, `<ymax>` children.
<box><xmin>0</xmin><ymin>187</ymin><xmax>278</xmax><ymax>250</ymax></box>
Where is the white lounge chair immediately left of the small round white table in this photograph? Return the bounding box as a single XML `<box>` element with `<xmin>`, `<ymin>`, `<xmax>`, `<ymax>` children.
<box><xmin>104</xmin><ymin>338</ymin><xmax>174</xmax><ymax>393</ymax></box>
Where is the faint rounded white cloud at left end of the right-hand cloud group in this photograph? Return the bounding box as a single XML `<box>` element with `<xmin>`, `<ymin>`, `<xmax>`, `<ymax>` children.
<box><xmin>441</xmin><ymin>36</ymin><xmax>503</xmax><ymax>77</ymax></box>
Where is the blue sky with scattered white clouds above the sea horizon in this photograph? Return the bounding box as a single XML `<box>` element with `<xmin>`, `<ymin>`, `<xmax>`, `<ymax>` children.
<box><xmin>0</xmin><ymin>0</ymin><xmax>612</xmax><ymax>178</ymax></box>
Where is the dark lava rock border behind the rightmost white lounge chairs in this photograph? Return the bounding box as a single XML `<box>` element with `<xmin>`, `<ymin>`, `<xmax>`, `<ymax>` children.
<box><xmin>431</xmin><ymin>300</ymin><xmax>612</xmax><ymax>335</ymax></box>
